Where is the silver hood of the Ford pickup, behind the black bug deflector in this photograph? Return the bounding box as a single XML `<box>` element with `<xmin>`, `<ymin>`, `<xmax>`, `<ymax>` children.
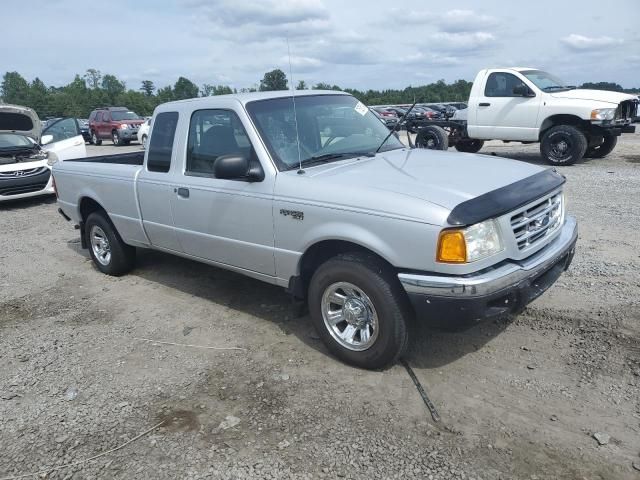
<box><xmin>283</xmin><ymin>149</ymin><xmax>544</xmax><ymax>224</ymax></box>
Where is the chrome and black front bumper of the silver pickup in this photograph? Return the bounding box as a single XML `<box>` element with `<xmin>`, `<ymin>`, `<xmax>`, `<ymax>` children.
<box><xmin>398</xmin><ymin>217</ymin><xmax>578</xmax><ymax>327</ymax></box>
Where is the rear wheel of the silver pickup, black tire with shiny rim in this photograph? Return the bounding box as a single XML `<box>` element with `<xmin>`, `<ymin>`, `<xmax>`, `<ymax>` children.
<box><xmin>84</xmin><ymin>212</ymin><xmax>136</xmax><ymax>276</ymax></box>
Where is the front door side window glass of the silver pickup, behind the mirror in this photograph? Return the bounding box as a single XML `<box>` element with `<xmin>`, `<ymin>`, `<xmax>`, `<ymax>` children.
<box><xmin>185</xmin><ymin>110</ymin><xmax>254</xmax><ymax>175</ymax></box>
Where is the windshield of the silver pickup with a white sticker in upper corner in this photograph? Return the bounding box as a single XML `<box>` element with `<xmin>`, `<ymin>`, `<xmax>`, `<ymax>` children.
<box><xmin>247</xmin><ymin>95</ymin><xmax>404</xmax><ymax>170</ymax></box>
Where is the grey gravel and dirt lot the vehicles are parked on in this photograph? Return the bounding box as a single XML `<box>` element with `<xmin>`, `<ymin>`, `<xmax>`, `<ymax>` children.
<box><xmin>0</xmin><ymin>134</ymin><xmax>640</xmax><ymax>480</ymax></box>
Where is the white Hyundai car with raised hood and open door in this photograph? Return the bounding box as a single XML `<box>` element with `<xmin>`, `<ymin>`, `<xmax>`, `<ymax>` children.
<box><xmin>0</xmin><ymin>105</ymin><xmax>87</xmax><ymax>202</ymax></box>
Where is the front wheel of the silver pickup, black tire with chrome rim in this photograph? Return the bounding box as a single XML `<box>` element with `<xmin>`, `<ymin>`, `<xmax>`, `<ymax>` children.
<box><xmin>308</xmin><ymin>253</ymin><xmax>412</xmax><ymax>369</ymax></box>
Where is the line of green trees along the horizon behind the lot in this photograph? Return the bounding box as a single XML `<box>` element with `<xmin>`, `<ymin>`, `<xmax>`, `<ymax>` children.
<box><xmin>0</xmin><ymin>68</ymin><xmax>640</xmax><ymax>118</ymax></box>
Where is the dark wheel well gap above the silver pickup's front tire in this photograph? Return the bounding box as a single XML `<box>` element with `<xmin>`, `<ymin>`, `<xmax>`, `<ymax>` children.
<box><xmin>289</xmin><ymin>240</ymin><xmax>393</xmax><ymax>298</ymax></box>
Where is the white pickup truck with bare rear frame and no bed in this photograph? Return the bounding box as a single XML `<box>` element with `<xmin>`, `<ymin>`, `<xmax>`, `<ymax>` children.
<box><xmin>408</xmin><ymin>67</ymin><xmax>638</xmax><ymax>165</ymax></box>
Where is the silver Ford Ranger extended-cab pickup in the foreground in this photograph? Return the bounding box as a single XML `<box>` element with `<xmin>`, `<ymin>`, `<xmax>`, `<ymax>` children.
<box><xmin>53</xmin><ymin>91</ymin><xmax>577</xmax><ymax>368</ymax></box>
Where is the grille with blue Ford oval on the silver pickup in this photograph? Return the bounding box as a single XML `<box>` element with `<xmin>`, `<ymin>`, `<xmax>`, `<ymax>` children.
<box><xmin>511</xmin><ymin>192</ymin><xmax>564</xmax><ymax>250</ymax></box>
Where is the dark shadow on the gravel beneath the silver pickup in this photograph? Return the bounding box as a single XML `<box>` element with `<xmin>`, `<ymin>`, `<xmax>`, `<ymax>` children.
<box><xmin>117</xmin><ymin>246</ymin><xmax>507</xmax><ymax>369</ymax></box>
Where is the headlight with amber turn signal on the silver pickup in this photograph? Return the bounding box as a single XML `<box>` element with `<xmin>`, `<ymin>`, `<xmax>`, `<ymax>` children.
<box><xmin>436</xmin><ymin>220</ymin><xmax>504</xmax><ymax>263</ymax></box>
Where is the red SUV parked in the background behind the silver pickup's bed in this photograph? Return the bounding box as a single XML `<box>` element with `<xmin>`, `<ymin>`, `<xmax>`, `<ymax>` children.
<box><xmin>89</xmin><ymin>107</ymin><xmax>144</xmax><ymax>146</ymax></box>
